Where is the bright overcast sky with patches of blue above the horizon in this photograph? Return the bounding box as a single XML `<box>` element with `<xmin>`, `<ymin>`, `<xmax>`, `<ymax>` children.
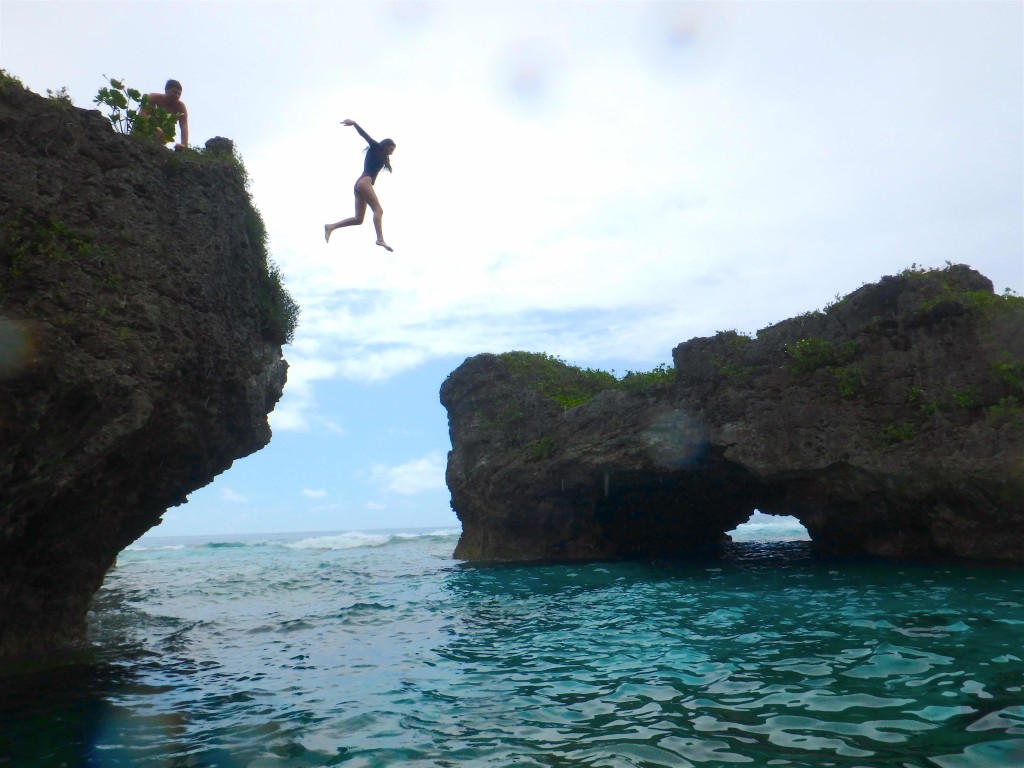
<box><xmin>0</xmin><ymin>0</ymin><xmax>1024</xmax><ymax>535</ymax></box>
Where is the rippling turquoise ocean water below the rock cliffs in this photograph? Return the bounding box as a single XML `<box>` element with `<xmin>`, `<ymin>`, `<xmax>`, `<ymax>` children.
<box><xmin>0</xmin><ymin>524</ymin><xmax>1024</xmax><ymax>768</ymax></box>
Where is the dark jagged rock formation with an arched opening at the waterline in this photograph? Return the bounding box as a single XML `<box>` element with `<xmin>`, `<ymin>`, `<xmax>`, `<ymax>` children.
<box><xmin>440</xmin><ymin>266</ymin><xmax>1024</xmax><ymax>562</ymax></box>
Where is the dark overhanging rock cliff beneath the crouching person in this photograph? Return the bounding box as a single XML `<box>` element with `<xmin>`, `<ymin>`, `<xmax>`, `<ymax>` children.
<box><xmin>0</xmin><ymin>83</ymin><xmax>287</xmax><ymax>658</ymax></box>
